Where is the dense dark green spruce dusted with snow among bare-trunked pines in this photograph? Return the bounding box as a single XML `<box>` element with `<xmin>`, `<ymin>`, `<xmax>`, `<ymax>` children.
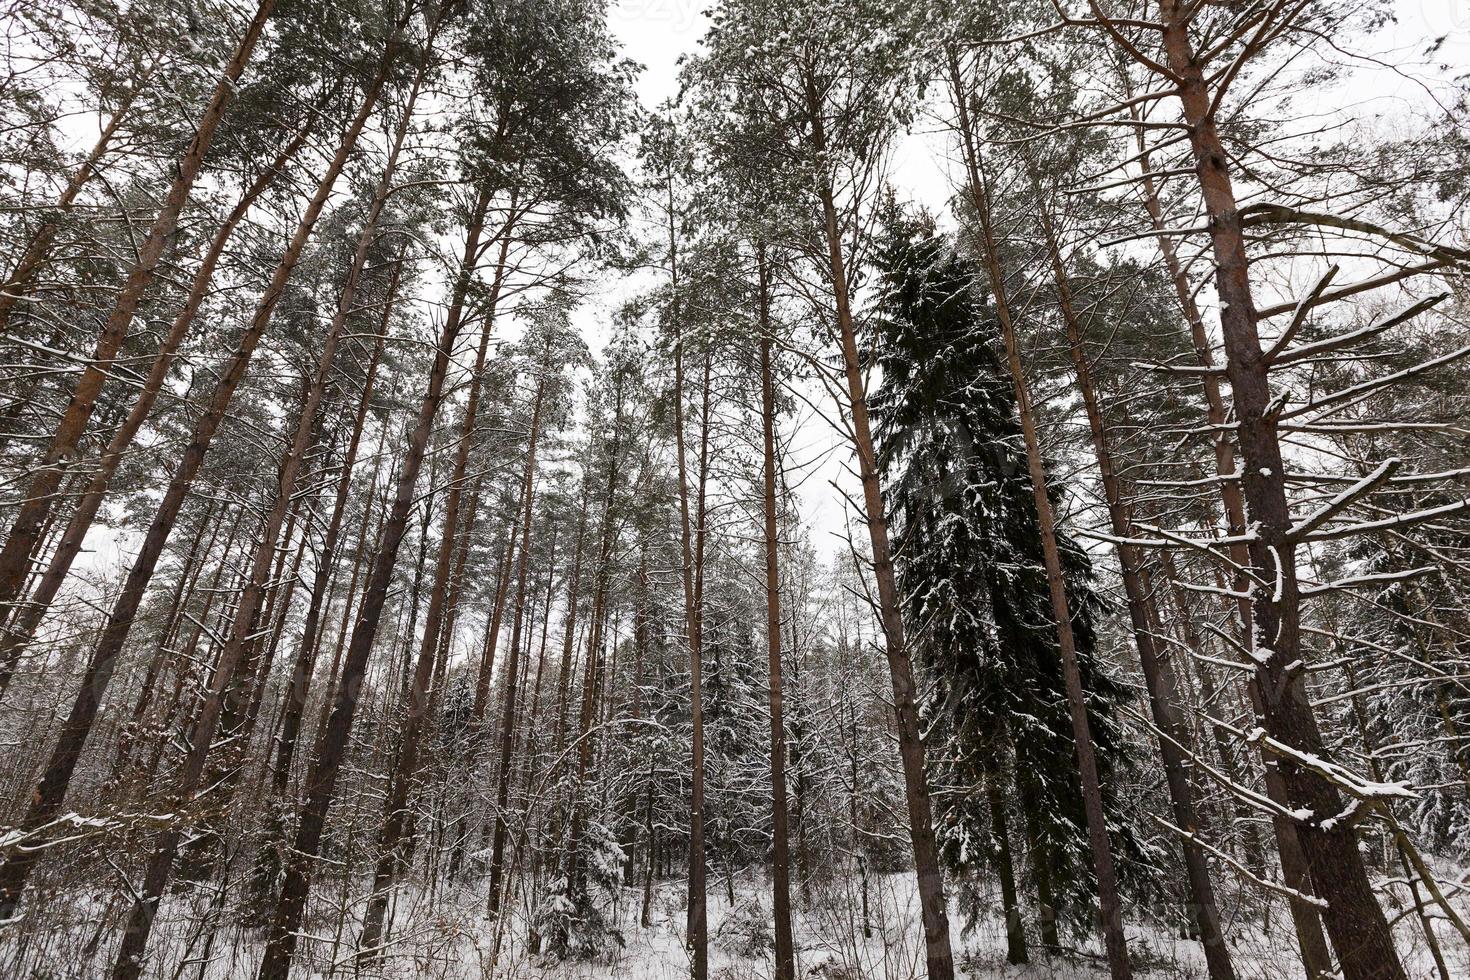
<box><xmin>870</xmin><ymin>204</ymin><xmax>1139</xmax><ymax>962</ymax></box>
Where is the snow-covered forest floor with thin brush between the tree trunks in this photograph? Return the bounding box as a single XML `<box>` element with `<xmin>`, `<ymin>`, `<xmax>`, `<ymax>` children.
<box><xmin>11</xmin><ymin>864</ymin><xmax>1470</xmax><ymax>980</ymax></box>
